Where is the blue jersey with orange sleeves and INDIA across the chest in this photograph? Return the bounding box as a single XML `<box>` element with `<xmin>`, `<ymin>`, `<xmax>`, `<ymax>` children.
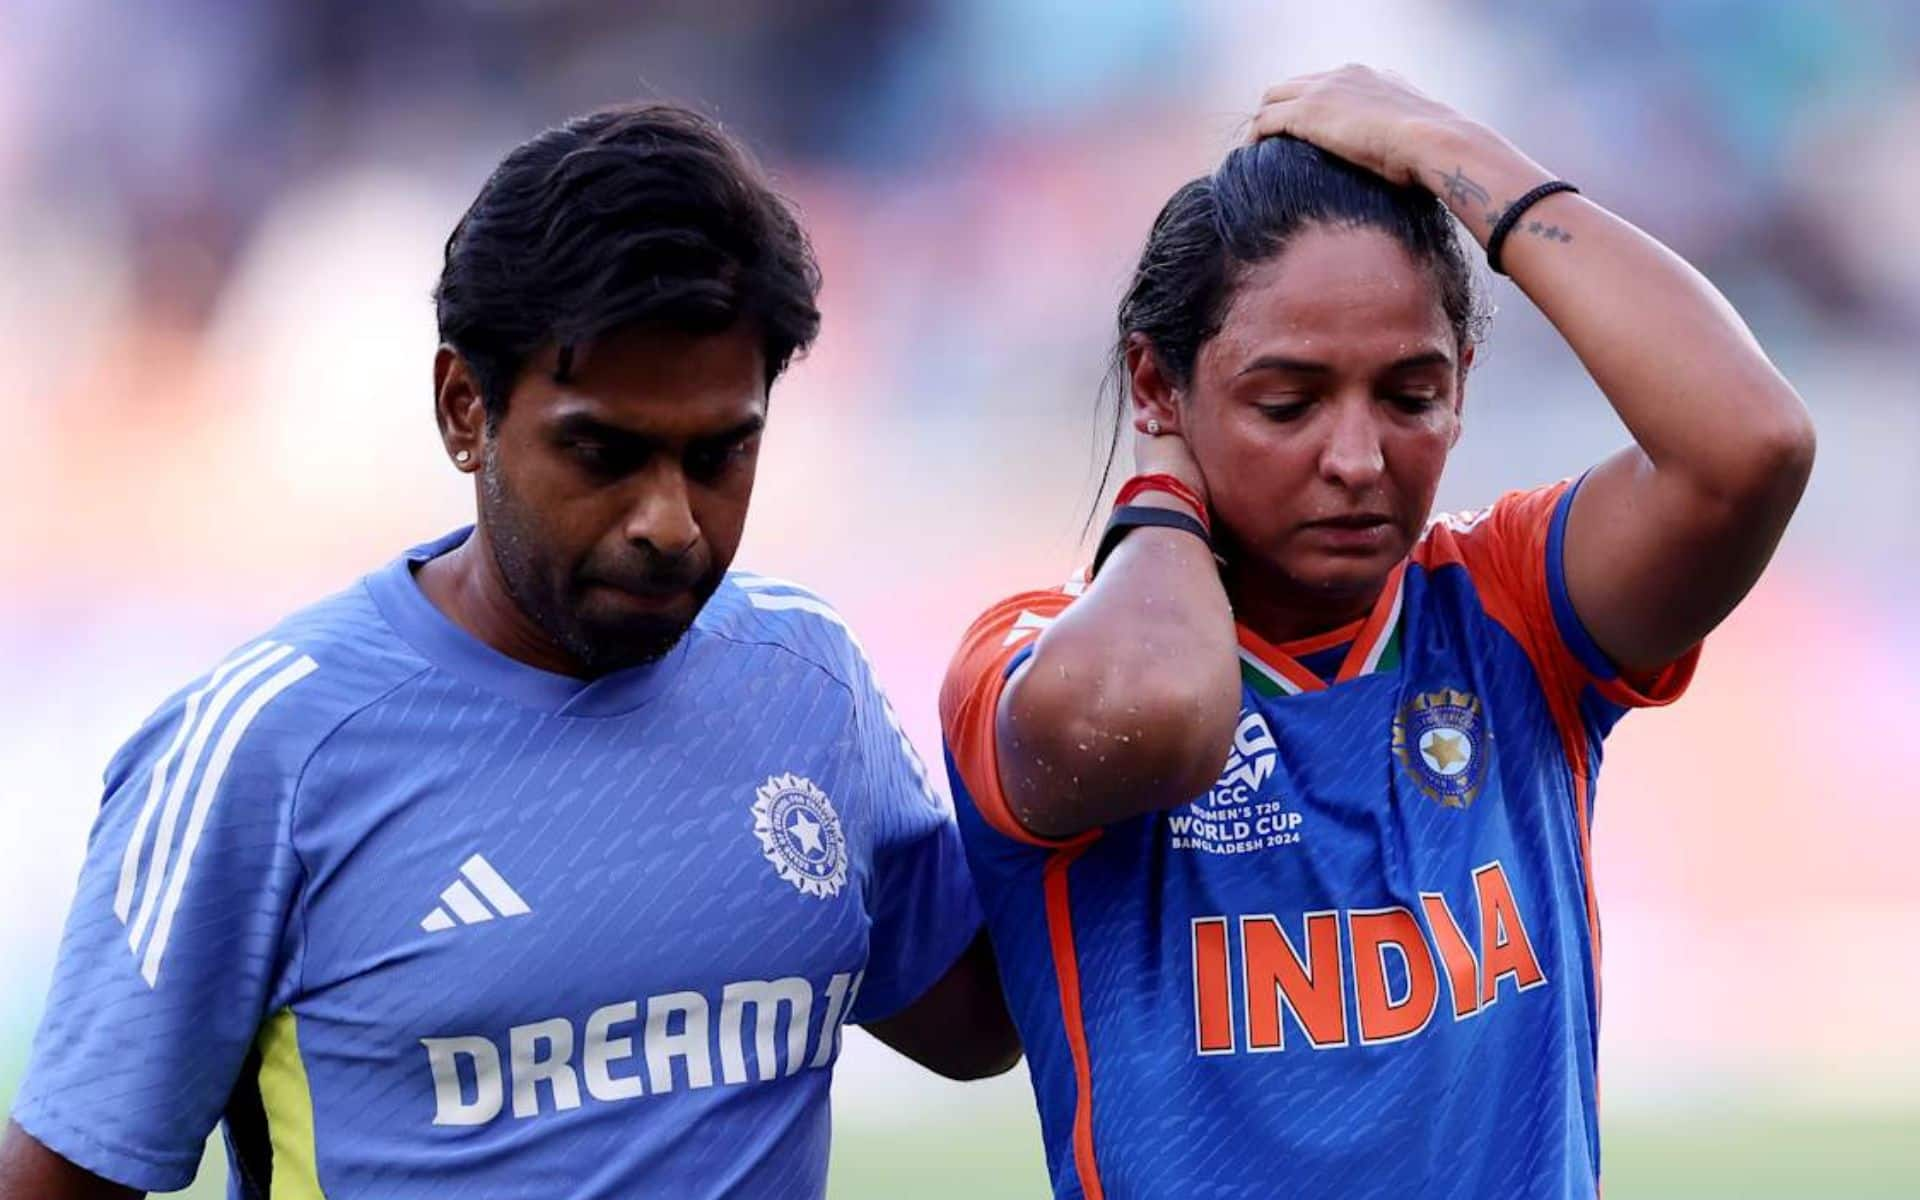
<box><xmin>941</xmin><ymin>484</ymin><xmax>1695</xmax><ymax>1200</ymax></box>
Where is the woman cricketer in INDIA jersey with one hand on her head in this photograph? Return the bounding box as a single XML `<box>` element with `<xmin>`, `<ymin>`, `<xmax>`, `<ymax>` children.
<box><xmin>941</xmin><ymin>67</ymin><xmax>1814</xmax><ymax>1200</ymax></box>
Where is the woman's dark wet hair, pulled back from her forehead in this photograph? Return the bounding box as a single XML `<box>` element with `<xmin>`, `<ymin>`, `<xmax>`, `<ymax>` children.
<box><xmin>1100</xmin><ymin>136</ymin><xmax>1486</xmax><ymax>492</ymax></box>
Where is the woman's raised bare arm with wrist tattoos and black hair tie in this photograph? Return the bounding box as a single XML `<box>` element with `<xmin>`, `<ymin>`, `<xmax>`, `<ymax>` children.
<box><xmin>1415</xmin><ymin>123</ymin><xmax>1814</xmax><ymax>670</ymax></box>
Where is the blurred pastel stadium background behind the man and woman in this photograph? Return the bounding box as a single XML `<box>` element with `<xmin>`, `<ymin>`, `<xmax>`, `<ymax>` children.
<box><xmin>0</xmin><ymin>0</ymin><xmax>1920</xmax><ymax>1200</ymax></box>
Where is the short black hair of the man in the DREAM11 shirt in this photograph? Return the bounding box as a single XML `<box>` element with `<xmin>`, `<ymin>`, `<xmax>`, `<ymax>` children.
<box><xmin>434</xmin><ymin>104</ymin><xmax>820</xmax><ymax>422</ymax></box>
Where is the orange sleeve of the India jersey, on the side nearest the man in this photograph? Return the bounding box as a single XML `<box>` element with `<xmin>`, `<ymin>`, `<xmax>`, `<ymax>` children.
<box><xmin>941</xmin><ymin>589</ymin><xmax>1094</xmax><ymax>849</ymax></box>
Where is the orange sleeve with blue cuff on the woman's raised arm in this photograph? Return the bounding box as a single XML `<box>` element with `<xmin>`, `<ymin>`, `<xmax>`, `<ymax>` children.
<box><xmin>1415</xmin><ymin>480</ymin><xmax>1699</xmax><ymax>712</ymax></box>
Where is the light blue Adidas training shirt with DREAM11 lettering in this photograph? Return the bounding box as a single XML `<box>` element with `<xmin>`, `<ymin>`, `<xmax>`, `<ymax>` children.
<box><xmin>12</xmin><ymin>530</ymin><xmax>981</xmax><ymax>1196</ymax></box>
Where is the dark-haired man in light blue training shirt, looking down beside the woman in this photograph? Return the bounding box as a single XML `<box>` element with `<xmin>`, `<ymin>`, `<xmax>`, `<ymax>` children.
<box><xmin>0</xmin><ymin>106</ymin><xmax>1020</xmax><ymax>1200</ymax></box>
